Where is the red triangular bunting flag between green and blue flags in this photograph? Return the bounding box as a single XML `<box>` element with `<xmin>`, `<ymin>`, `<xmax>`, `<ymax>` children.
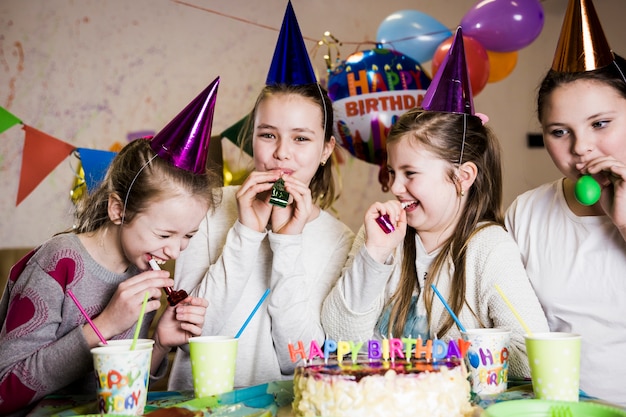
<box><xmin>15</xmin><ymin>125</ymin><xmax>76</xmax><ymax>206</ymax></box>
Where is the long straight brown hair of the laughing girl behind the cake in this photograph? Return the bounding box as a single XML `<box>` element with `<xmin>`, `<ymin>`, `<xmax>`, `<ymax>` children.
<box><xmin>387</xmin><ymin>109</ymin><xmax>504</xmax><ymax>337</ymax></box>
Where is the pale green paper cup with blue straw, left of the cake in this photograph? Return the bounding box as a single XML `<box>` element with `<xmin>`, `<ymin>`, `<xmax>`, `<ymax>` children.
<box><xmin>189</xmin><ymin>336</ymin><xmax>238</xmax><ymax>398</ymax></box>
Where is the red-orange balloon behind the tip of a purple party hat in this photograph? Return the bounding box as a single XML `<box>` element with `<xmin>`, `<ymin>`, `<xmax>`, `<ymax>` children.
<box><xmin>431</xmin><ymin>35</ymin><xmax>489</xmax><ymax>96</ymax></box>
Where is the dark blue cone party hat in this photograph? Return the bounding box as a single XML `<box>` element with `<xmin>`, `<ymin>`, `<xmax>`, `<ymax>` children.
<box><xmin>265</xmin><ymin>1</ymin><xmax>317</xmax><ymax>85</ymax></box>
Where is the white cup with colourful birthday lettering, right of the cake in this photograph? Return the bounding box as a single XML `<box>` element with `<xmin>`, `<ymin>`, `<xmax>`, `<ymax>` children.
<box><xmin>461</xmin><ymin>329</ymin><xmax>511</xmax><ymax>398</ymax></box>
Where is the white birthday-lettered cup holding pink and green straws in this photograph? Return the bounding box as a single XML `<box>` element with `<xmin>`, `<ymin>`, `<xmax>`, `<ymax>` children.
<box><xmin>91</xmin><ymin>343</ymin><xmax>152</xmax><ymax>416</ymax></box>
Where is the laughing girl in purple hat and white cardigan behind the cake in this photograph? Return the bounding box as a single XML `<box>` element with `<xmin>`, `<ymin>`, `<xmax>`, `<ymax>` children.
<box><xmin>322</xmin><ymin>27</ymin><xmax>548</xmax><ymax>377</ymax></box>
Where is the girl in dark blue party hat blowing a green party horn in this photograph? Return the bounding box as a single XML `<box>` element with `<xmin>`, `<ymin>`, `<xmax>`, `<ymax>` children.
<box><xmin>169</xmin><ymin>3</ymin><xmax>354</xmax><ymax>390</ymax></box>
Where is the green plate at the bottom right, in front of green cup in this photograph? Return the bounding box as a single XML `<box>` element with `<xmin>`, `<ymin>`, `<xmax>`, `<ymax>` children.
<box><xmin>482</xmin><ymin>400</ymin><xmax>626</xmax><ymax>417</ymax></box>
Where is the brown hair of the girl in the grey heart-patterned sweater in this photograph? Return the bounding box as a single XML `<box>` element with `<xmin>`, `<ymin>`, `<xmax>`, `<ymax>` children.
<box><xmin>72</xmin><ymin>139</ymin><xmax>221</xmax><ymax>233</ymax></box>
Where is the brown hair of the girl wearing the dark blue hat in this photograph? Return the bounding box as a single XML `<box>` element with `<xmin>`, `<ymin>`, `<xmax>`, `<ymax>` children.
<box><xmin>238</xmin><ymin>84</ymin><xmax>340</xmax><ymax>209</ymax></box>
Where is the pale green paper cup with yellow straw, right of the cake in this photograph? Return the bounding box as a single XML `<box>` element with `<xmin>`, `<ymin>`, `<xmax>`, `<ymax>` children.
<box><xmin>524</xmin><ymin>332</ymin><xmax>581</xmax><ymax>401</ymax></box>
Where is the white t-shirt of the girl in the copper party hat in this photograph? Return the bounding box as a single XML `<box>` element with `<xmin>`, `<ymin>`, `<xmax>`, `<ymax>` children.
<box><xmin>506</xmin><ymin>179</ymin><xmax>626</xmax><ymax>406</ymax></box>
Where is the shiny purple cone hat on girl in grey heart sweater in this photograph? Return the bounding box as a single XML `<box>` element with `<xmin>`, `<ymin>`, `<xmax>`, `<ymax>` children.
<box><xmin>150</xmin><ymin>77</ymin><xmax>220</xmax><ymax>174</ymax></box>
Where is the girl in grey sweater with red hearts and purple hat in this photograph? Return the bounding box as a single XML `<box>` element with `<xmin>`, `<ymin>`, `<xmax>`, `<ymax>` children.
<box><xmin>0</xmin><ymin>78</ymin><xmax>219</xmax><ymax>415</ymax></box>
